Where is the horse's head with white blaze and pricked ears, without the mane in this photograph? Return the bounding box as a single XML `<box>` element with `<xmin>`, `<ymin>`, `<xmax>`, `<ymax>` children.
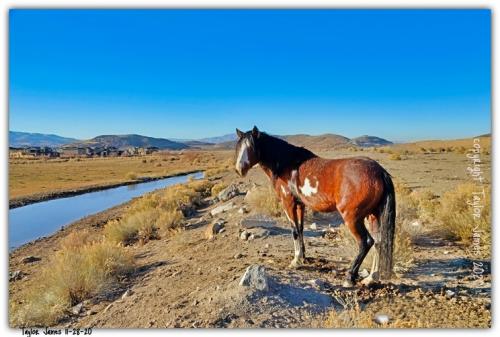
<box><xmin>236</xmin><ymin>126</ymin><xmax>260</xmax><ymax>177</ymax></box>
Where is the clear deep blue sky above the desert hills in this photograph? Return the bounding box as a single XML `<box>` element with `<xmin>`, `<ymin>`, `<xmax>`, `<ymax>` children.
<box><xmin>9</xmin><ymin>10</ymin><xmax>491</xmax><ymax>141</ymax></box>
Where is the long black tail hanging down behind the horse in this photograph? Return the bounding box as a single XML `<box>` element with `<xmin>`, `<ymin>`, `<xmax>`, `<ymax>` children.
<box><xmin>378</xmin><ymin>170</ymin><xmax>396</xmax><ymax>280</ymax></box>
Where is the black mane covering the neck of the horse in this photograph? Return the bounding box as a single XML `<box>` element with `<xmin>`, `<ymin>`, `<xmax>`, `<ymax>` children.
<box><xmin>255</xmin><ymin>132</ymin><xmax>317</xmax><ymax>177</ymax></box>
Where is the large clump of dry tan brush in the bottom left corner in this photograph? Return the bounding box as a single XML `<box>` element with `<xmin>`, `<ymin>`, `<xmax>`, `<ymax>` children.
<box><xmin>11</xmin><ymin>233</ymin><xmax>133</xmax><ymax>326</ymax></box>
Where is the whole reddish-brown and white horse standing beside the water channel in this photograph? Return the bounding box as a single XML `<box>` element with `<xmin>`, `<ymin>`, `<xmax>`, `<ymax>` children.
<box><xmin>235</xmin><ymin>127</ymin><xmax>396</xmax><ymax>287</ymax></box>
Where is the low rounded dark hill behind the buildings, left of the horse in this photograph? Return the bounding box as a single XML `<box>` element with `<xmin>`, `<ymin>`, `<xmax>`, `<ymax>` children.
<box><xmin>68</xmin><ymin>135</ymin><xmax>189</xmax><ymax>150</ymax></box>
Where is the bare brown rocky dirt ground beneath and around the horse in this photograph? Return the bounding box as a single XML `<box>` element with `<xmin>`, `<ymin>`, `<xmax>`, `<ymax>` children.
<box><xmin>9</xmin><ymin>152</ymin><xmax>491</xmax><ymax>328</ymax></box>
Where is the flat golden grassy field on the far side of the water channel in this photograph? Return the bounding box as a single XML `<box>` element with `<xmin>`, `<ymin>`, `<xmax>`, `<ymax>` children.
<box><xmin>9</xmin><ymin>151</ymin><xmax>229</xmax><ymax>199</ymax></box>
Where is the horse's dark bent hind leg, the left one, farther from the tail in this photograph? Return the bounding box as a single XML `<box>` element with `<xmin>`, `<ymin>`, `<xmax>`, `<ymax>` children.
<box><xmin>344</xmin><ymin>218</ymin><xmax>373</xmax><ymax>287</ymax></box>
